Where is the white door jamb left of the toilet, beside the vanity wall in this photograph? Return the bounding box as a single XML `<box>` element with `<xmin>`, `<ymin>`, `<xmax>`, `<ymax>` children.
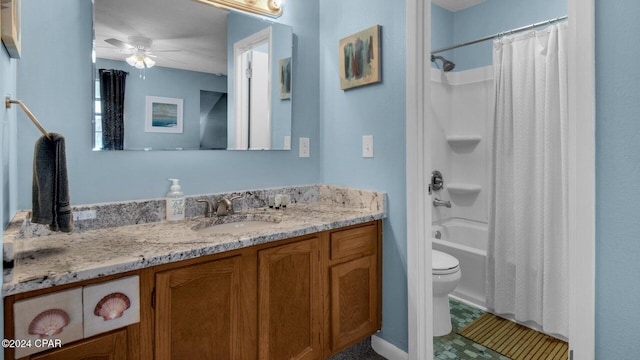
<box><xmin>406</xmin><ymin>0</ymin><xmax>433</xmax><ymax>360</ymax></box>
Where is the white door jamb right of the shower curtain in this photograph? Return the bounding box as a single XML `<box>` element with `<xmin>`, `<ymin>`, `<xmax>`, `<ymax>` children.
<box><xmin>568</xmin><ymin>0</ymin><xmax>596</xmax><ymax>360</ymax></box>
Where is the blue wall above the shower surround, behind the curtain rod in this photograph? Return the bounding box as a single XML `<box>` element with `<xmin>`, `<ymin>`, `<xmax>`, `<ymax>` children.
<box><xmin>431</xmin><ymin>0</ymin><xmax>567</xmax><ymax>71</ymax></box>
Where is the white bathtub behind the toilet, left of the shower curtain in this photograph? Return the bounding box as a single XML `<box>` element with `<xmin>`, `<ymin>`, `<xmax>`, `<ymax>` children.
<box><xmin>432</xmin><ymin>219</ymin><xmax>488</xmax><ymax>309</ymax></box>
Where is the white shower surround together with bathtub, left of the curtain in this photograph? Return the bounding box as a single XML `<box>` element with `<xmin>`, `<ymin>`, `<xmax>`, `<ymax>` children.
<box><xmin>430</xmin><ymin>66</ymin><xmax>494</xmax><ymax>308</ymax></box>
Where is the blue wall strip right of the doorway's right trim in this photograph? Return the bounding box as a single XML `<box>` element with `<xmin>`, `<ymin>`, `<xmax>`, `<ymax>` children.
<box><xmin>595</xmin><ymin>0</ymin><xmax>640</xmax><ymax>359</ymax></box>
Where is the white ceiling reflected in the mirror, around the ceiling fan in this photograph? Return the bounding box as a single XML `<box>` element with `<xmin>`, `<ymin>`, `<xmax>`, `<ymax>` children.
<box><xmin>93</xmin><ymin>0</ymin><xmax>228</xmax><ymax>74</ymax></box>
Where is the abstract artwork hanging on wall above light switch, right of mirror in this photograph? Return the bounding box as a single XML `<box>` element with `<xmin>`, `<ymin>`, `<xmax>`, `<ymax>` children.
<box><xmin>339</xmin><ymin>25</ymin><xmax>380</xmax><ymax>90</ymax></box>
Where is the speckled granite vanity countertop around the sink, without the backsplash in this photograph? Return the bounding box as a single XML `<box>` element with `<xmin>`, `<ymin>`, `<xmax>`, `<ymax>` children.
<box><xmin>2</xmin><ymin>202</ymin><xmax>385</xmax><ymax>296</ymax></box>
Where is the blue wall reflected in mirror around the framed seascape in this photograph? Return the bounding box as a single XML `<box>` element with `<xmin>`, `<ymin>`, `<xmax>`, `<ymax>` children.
<box><xmin>96</xmin><ymin>59</ymin><xmax>227</xmax><ymax>150</ymax></box>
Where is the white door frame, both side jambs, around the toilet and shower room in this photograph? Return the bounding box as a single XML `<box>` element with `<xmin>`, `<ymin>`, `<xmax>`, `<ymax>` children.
<box><xmin>406</xmin><ymin>0</ymin><xmax>595</xmax><ymax>360</ymax></box>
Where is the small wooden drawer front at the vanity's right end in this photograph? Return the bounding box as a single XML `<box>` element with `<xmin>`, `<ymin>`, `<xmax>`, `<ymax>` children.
<box><xmin>331</xmin><ymin>224</ymin><xmax>378</xmax><ymax>260</ymax></box>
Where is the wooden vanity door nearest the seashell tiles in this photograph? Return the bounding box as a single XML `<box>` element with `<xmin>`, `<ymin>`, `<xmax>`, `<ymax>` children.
<box><xmin>155</xmin><ymin>256</ymin><xmax>242</xmax><ymax>360</ymax></box>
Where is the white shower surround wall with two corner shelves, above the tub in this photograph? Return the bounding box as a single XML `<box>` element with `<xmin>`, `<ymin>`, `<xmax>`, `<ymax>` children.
<box><xmin>430</xmin><ymin>66</ymin><xmax>494</xmax><ymax>225</ymax></box>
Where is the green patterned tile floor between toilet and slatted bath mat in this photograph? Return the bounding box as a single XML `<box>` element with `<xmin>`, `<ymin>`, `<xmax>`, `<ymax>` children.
<box><xmin>433</xmin><ymin>298</ymin><xmax>509</xmax><ymax>360</ymax></box>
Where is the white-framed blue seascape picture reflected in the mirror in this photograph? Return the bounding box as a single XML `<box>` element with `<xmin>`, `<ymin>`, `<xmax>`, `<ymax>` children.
<box><xmin>144</xmin><ymin>96</ymin><xmax>184</xmax><ymax>134</ymax></box>
